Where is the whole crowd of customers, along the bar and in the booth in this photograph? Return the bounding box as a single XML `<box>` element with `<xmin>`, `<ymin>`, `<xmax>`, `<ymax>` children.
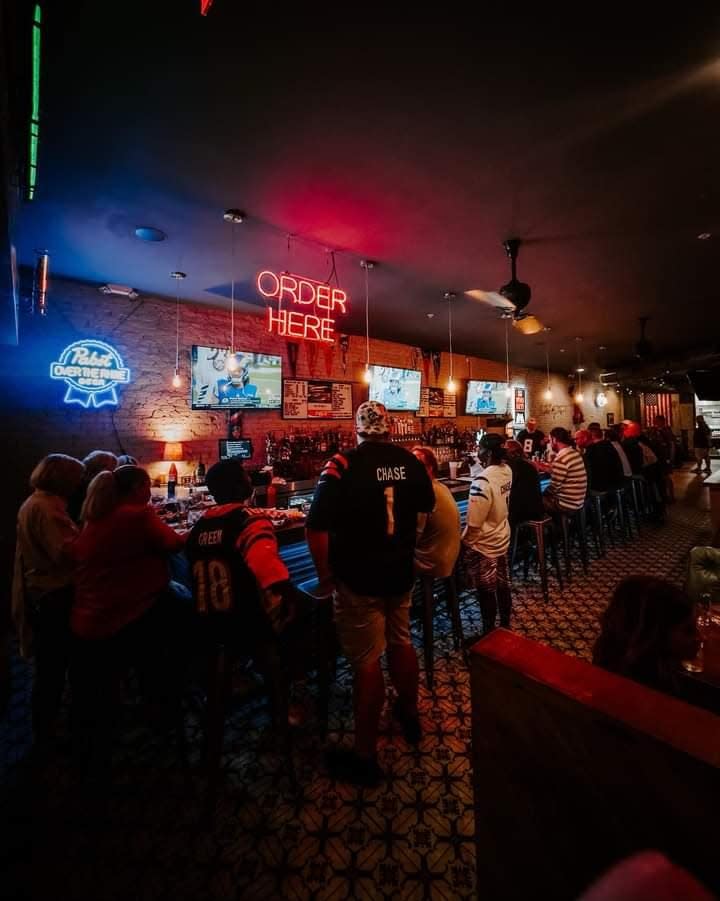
<box><xmin>13</xmin><ymin>401</ymin><xmax>700</xmax><ymax>785</ymax></box>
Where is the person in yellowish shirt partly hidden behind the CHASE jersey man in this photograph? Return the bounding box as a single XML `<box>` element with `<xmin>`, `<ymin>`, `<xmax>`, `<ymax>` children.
<box><xmin>412</xmin><ymin>445</ymin><xmax>460</xmax><ymax>579</ymax></box>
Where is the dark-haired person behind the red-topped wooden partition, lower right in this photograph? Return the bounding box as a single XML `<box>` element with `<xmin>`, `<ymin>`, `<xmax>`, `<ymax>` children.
<box><xmin>593</xmin><ymin>576</ymin><xmax>700</xmax><ymax>694</ymax></box>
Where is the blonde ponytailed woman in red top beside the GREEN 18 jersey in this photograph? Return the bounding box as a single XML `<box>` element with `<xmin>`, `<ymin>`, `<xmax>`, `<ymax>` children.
<box><xmin>70</xmin><ymin>466</ymin><xmax>185</xmax><ymax>762</ymax></box>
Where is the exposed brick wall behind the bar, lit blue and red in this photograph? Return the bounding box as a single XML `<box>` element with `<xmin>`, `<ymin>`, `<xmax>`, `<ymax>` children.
<box><xmin>0</xmin><ymin>279</ymin><xmax>619</xmax><ymax>596</ymax></box>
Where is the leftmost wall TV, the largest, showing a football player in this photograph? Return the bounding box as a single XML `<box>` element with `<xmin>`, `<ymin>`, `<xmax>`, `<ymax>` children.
<box><xmin>190</xmin><ymin>345</ymin><xmax>282</xmax><ymax>410</ymax></box>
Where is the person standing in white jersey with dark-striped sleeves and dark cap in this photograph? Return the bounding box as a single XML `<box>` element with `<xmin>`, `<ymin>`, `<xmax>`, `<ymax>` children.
<box><xmin>462</xmin><ymin>434</ymin><xmax>512</xmax><ymax>634</ymax></box>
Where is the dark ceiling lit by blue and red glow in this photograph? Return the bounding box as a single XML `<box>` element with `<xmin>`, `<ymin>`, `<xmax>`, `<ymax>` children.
<box><xmin>12</xmin><ymin>0</ymin><xmax>720</xmax><ymax>376</ymax></box>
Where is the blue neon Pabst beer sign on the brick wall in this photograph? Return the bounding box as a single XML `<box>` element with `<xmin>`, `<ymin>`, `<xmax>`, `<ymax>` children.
<box><xmin>50</xmin><ymin>339</ymin><xmax>130</xmax><ymax>408</ymax></box>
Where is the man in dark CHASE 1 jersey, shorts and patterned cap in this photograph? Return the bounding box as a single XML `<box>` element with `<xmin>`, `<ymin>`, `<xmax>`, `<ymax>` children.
<box><xmin>307</xmin><ymin>401</ymin><xmax>435</xmax><ymax>786</ymax></box>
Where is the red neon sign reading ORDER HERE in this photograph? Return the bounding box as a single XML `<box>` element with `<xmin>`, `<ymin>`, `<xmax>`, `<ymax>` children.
<box><xmin>255</xmin><ymin>269</ymin><xmax>348</xmax><ymax>344</ymax></box>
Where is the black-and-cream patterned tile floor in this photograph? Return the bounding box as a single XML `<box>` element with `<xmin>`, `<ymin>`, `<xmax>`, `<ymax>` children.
<box><xmin>0</xmin><ymin>474</ymin><xmax>709</xmax><ymax>901</ymax></box>
